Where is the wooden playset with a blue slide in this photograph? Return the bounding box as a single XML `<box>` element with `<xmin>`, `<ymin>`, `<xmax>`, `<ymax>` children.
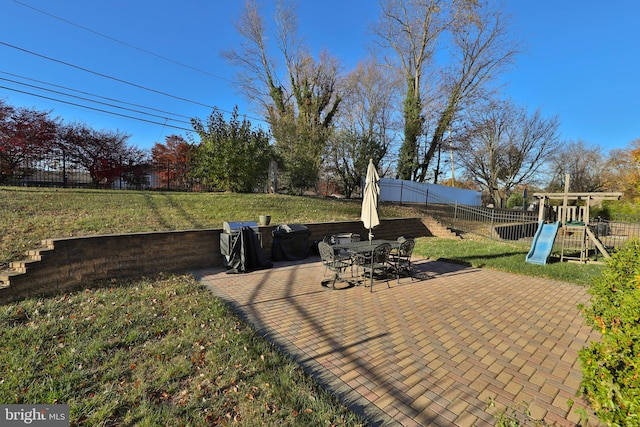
<box><xmin>526</xmin><ymin>176</ymin><xmax>622</xmax><ymax>264</ymax></box>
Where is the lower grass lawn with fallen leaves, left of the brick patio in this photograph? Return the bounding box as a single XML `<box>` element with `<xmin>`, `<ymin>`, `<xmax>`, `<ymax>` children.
<box><xmin>0</xmin><ymin>276</ymin><xmax>362</xmax><ymax>427</ymax></box>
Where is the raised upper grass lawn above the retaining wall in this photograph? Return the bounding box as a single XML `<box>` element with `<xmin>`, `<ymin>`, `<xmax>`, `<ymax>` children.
<box><xmin>0</xmin><ymin>187</ymin><xmax>416</xmax><ymax>267</ymax></box>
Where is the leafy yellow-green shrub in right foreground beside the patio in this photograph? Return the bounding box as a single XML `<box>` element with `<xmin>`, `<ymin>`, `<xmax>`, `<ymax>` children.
<box><xmin>579</xmin><ymin>239</ymin><xmax>640</xmax><ymax>426</ymax></box>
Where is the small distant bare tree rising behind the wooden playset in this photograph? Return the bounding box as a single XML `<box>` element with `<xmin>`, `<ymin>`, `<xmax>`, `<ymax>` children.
<box><xmin>547</xmin><ymin>141</ymin><xmax>605</xmax><ymax>193</ymax></box>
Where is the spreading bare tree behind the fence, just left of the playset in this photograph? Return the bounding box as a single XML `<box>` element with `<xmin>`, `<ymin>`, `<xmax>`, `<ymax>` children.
<box><xmin>459</xmin><ymin>102</ymin><xmax>560</xmax><ymax>206</ymax></box>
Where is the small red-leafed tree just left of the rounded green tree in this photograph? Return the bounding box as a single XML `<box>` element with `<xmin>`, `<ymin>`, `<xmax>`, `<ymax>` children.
<box><xmin>151</xmin><ymin>135</ymin><xmax>193</xmax><ymax>188</ymax></box>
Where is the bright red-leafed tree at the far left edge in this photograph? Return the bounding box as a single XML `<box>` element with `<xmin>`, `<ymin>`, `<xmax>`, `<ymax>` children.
<box><xmin>0</xmin><ymin>100</ymin><xmax>59</xmax><ymax>183</ymax></box>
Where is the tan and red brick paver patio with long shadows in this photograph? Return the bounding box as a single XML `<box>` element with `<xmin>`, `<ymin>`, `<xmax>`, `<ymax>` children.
<box><xmin>197</xmin><ymin>258</ymin><xmax>598</xmax><ymax>426</ymax></box>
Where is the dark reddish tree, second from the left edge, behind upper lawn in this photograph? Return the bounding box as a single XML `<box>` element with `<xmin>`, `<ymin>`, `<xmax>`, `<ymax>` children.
<box><xmin>60</xmin><ymin>123</ymin><xmax>145</xmax><ymax>187</ymax></box>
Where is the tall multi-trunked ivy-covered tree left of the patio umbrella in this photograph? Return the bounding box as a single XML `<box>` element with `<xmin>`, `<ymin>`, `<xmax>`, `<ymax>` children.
<box><xmin>223</xmin><ymin>0</ymin><xmax>341</xmax><ymax>194</ymax></box>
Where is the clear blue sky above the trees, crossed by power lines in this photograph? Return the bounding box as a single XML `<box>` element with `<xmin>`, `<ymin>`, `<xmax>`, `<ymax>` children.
<box><xmin>0</xmin><ymin>0</ymin><xmax>640</xmax><ymax>151</ymax></box>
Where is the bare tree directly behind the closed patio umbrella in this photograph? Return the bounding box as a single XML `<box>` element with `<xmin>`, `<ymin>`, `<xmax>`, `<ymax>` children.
<box><xmin>325</xmin><ymin>58</ymin><xmax>398</xmax><ymax>197</ymax></box>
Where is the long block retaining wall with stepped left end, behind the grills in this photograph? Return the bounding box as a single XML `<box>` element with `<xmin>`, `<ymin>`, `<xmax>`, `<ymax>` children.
<box><xmin>0</xmin><ymin>218</ymin><xmax>432</xmax><ymax>303</ymax></box>
